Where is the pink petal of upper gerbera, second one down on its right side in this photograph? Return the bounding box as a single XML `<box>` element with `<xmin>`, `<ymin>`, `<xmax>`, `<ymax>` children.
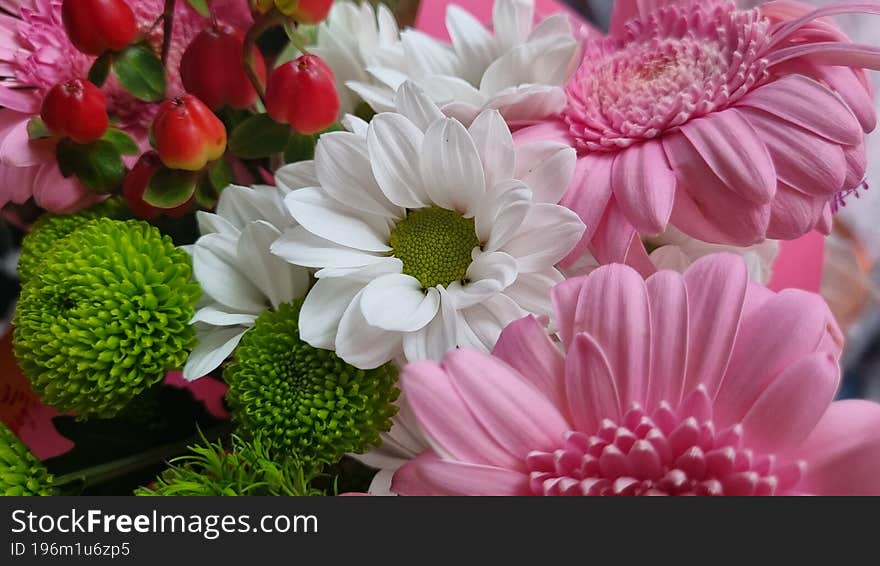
<box><xmin>741</xmin><ymin>108</ymin><xmax>846</xmax><ymax>197</ymax></box>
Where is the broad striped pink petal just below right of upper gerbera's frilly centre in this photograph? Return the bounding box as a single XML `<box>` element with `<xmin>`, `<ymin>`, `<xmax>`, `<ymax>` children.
<box><xmin>681</xmin><ymin>108</ymin><xmax>776</xmax><ymax>204</ymax></box>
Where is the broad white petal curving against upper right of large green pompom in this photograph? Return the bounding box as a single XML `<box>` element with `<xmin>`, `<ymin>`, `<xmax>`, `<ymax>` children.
<box><xmin>193</xmin><ymin>234</ymin><xmax>268</xmax><ymax>313</ymax></box>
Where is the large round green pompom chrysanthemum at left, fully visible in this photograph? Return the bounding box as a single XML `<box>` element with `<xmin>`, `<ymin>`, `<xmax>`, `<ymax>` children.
<box><xmin>14</xmin><ymin>218</ymin><xmax>200</xmax><ymax>417</ymax></box>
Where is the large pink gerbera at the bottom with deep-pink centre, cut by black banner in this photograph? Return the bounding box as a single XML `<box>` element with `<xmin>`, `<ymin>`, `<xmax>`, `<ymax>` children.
<box><xmin>393</xmin><ymin>254</ymin><xmax>880</xmax><ymax>495</ymax></box>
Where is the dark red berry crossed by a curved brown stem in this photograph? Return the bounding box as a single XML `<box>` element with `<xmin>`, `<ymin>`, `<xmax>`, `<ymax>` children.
<box><xmin>180</xmin><ymin>24</ymin><xmax>266</xmax><ymax>110</ymax></box>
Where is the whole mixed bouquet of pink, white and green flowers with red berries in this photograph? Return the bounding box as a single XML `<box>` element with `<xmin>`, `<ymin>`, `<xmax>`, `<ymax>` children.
<box><xmin>0</xmin><ymin>0</ymin><xmax>880</xmax><ymax>495</ymax></box>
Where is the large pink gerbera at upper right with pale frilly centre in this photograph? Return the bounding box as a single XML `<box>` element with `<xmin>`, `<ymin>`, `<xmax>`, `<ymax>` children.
<box><xmin>519</xmin><ymin>0</ymin><xmax>880</xmax><ymax>272</ymax></box>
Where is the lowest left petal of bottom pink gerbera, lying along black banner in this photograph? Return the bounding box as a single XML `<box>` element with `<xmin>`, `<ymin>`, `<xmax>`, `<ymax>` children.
<box><xmin>391</xmin><ymin>452</ymin><xmax>531</xmax><ymax>496</ymax></box>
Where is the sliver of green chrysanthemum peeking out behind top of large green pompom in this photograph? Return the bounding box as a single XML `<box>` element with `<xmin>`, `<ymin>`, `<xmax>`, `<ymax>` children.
<box><xmin>18</xmin><ymin>198</ymin><xmax>125</xmax><ymax>282</ymax></box>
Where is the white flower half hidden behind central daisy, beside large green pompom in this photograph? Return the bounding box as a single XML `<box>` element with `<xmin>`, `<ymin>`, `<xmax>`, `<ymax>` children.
<box><xmin>183</xmin><ymin>185</ymin><xmax>309</xmax><ymax>381</ymax></box>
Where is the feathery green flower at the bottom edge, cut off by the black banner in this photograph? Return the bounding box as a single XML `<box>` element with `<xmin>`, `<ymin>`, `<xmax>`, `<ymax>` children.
<box><xmin>135</xmin><ymin>438</ymin><xmax>325</xmax><ymax>496</ymax></box>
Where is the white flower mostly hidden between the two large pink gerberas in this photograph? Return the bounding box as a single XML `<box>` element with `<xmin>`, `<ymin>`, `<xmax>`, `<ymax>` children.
<box><xmin>563</xmin><ymin>224</ymin><xmax>779</xmax><ymax>285</ymax></box>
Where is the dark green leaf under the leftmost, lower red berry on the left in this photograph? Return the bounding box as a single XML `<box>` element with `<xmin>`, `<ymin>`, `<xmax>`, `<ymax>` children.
<box><xmin>56</xmin><ymin>139</ymin><xmax>125</xmax><ymax>193</ymax></box>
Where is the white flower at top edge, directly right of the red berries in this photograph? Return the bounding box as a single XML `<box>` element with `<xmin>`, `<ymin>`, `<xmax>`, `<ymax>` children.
<box><xmin>309</xmin><ymin>0</ymin><xmax>402</xmax><ymax>116</ymax></box>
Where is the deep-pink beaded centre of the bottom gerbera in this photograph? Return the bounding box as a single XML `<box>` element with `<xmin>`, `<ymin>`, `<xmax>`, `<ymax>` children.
<box><xmin>526</xmin><ymin>390</ymin><xmax>805</xmax><ymax>495</ymax></box>
